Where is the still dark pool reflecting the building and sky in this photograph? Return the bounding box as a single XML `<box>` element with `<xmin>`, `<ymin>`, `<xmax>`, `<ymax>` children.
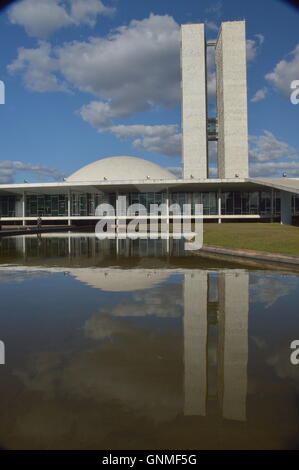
<box><xmin>0</xmin><ymin>234</ymin><xmax>299</xmax><ymax>449</ymax></box>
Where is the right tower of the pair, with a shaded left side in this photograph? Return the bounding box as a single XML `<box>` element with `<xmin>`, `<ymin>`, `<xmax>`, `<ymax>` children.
<box><xmin>216</xmin><ymin>21</ymin><xmax>248</xmax><ymax>178</ymax></box>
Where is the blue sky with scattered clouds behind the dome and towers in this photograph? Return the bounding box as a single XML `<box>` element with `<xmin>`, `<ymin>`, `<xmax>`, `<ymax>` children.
<box><xmin>0</xmin><ymin>0</ymin><xmax>299</xmax><ymax>183</ymax></box>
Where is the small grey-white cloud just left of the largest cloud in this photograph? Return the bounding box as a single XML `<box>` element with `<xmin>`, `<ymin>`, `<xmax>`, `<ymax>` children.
<box><xmin>7</xmin><ymin>41</ymin><xmax>67</xmax><ymax>93</ymax></box>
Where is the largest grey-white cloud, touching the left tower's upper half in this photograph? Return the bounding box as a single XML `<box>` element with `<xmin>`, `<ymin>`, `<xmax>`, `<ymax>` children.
<box><xmin>58</xmin><ymin>15</ymin><xmax>180</xmax><ymax>111</ymax></box>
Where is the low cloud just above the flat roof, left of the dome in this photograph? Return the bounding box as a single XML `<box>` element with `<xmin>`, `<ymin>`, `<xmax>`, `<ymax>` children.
<box><xmin>0</xmin><ymin>160</ymin><xmax>63</xmax><ymax>184</ymax></box>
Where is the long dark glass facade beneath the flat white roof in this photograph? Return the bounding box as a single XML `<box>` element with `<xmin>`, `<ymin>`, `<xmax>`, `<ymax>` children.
<box><xmin>0</xmin><ymin>190</ymin><xmax>299</xmax><ymax>217</ymax></box>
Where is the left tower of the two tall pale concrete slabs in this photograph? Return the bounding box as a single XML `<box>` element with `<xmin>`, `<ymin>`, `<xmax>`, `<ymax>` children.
<box><xmin>181</xmin><ymin>24</ymin><xmax>208</xmax><ymax>179</ymax></box>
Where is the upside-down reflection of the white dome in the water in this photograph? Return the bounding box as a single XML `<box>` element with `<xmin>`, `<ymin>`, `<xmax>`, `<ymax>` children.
<box><xmin>70</xmin><ymin>268</ymin><xmax>170</xmax><ymax>292</ymax></box>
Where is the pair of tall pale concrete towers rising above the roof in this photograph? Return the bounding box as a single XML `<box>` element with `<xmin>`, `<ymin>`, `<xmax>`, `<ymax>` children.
<box><xmin>181</xmin><ymin>21</ymin><xmax>248</xmax><ymax>179</ymax></box>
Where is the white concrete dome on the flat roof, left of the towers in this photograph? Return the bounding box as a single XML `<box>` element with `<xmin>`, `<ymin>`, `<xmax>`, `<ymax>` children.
<box><xmin>67</xmin><ymin>157</ymin><xmax>176</xmax><ymax>182</ymax></box>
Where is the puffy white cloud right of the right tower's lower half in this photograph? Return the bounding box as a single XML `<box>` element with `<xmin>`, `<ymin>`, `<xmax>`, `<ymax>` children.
<box><xmin>249</xmin><ymin>131</ymin><xmax>298</xmax><ymax>162</ymax></box>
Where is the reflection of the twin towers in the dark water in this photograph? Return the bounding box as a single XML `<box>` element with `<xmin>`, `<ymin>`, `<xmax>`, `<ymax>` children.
<box><xmin>184</xmin><ymin>270</ymin><xmax>249</xmax><ymax>421</ymax></box>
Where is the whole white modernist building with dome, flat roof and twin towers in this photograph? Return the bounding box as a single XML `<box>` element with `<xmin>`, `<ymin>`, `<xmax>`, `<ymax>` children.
<box><xmin>0</xmin><ymin>21</ymin><xmax>299</xmax><ymax>225</ymax></box>
